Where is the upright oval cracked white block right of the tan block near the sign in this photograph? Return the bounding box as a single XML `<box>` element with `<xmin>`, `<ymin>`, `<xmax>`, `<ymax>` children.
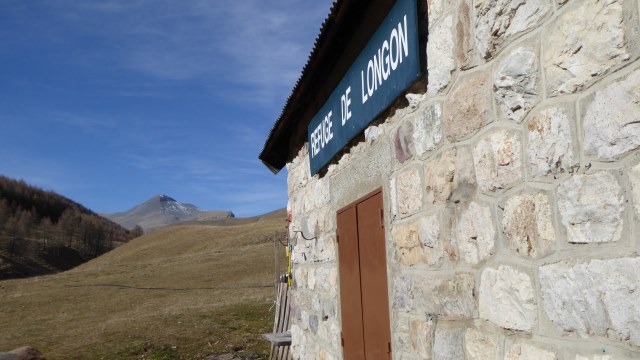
<box><xmin>493</xmin><ymin>47</ymin><xmax>538</xmax><ymax>124</ymax></box>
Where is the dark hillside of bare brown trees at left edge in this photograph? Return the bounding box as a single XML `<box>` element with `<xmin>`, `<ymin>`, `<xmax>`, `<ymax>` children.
<box><xmin>0</xmin><ymin>176</ymin><xmax>142</xmax><ymax>271</ymax></box>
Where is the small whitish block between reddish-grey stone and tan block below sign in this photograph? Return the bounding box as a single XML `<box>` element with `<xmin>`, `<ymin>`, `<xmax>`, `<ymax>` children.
<box><xmin>413</xmin><ymin>103</ymin><xmax>442</xmax><ymax>156</ymax></box>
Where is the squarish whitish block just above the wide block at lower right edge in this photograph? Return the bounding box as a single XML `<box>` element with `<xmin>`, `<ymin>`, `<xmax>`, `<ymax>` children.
<box><xmin>558</xmin><ymin>171</ymin><xmax>624</xmax><ymax>243</ymax></box>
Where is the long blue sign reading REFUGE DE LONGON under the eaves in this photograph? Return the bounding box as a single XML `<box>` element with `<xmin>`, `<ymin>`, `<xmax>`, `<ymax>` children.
<box><xmin>308</xmin><ymin>0</ymin><xmax>420</xmax><ymax>175</ymax></box>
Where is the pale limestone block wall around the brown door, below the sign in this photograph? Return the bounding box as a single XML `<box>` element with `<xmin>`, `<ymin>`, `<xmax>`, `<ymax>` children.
<box><xmin>287</xmin><ymin>0</ymin><xmax>640</xmax><ymax>360</ymax></box>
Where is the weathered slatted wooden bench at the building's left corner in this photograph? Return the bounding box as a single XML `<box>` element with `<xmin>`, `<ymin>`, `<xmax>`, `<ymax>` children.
<box><xmin>262</xmin><ymin>282</ymin><xmax>291</xmax><ymax>360</ymax></box>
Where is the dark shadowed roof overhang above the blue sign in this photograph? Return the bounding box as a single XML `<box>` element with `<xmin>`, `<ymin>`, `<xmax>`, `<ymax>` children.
<box><xmin>259</xmin><ymin>0</ymin><xmax>395</xmax><ymax>173</ymax></box>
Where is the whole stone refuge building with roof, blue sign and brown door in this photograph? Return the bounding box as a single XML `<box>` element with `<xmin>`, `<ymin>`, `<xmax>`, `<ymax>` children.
<box><xmin>260</xmin><ymin>0</ymin><xmax>640</xmax><ymax>360</ymax></box>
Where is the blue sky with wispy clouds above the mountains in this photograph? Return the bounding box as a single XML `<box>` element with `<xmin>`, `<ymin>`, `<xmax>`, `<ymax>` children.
<box><xmin>0</xmin><ymin>0</ymin><xmax>332</xmax><ymax>216</ymax></box>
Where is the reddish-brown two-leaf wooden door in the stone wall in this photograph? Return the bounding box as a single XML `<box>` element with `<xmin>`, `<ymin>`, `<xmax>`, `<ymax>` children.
<box><xmin>337</xmin><ymin>190</ymin><xmax>391</xmax><ymax>360</ymax></box>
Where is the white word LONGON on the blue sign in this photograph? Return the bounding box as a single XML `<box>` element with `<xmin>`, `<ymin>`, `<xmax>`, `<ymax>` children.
<box><xmin>362</xmin><ymin>15</ymin><xmax>409</xmax><ymax>104</ymax></box>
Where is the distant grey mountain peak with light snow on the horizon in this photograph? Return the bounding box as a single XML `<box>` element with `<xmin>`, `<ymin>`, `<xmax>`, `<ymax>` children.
<box><xmin>103</xmin><ymin>195</ymin><xmax>235</xmax><ymax>232</ymax></box>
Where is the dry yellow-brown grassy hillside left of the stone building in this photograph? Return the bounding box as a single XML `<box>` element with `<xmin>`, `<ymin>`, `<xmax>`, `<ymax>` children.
<box><xmin>0</xmin><ymin>218</ymin><xmax>285</xmax><ymax>360</ymax></box>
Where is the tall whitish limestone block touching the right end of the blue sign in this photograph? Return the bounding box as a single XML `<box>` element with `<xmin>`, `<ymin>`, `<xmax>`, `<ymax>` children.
<box><xmin>427</xmin><ymin>15</ymin><xmax>456</xmax><ymax>95</ymax></box>
